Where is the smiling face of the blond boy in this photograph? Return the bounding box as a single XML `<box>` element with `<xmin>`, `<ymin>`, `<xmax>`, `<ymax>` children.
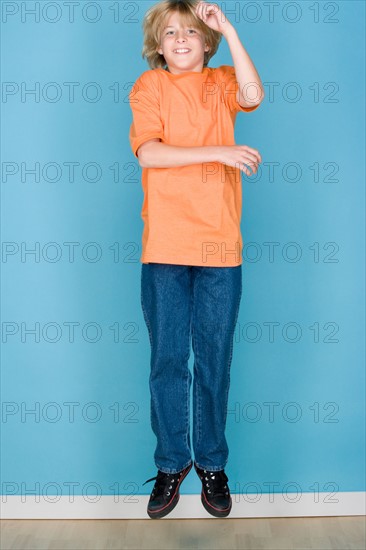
<box><xmin>156</xmin><ymin>12</ymin><xmax>209</xmax><ymax>74</ymax></box>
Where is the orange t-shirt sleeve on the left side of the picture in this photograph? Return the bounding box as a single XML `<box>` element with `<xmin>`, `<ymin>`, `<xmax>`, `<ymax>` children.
<box><xmin>129</xmin><ymin>69</ymin><xmax>164</xmax><ymax>157</ymax></box>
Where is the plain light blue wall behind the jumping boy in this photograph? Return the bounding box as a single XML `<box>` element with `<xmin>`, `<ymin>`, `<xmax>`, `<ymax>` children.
<box><xmin>1</xmin><ymin>1</ymin><xmax>365</xmax><ymax>500</ymax></box>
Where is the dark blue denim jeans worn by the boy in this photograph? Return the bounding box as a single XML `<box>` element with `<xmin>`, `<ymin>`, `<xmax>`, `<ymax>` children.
<box><xmin>141</xmin><ymin>263</ymin><xmax>242</xmax><ymax>474</ymax></box>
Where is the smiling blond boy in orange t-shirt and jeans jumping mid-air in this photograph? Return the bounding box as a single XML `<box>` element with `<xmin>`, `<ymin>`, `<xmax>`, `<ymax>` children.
<box><xmin>129</xmin><ymin>0</ymin><xmax>264</xmax><ymax>518</ymax></box>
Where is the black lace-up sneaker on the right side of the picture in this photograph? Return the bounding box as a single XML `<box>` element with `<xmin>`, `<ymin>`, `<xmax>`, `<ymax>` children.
<box><xmin>194</xmin><ymin>463</ymin><xmax>232</xmax><ymax>518</ymax></box>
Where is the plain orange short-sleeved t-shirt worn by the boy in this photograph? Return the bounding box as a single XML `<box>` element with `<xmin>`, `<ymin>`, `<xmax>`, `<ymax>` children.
<box><xmin>129</xmin><ymin>65</ymin><xmax>259</xmax><ymax>267</ymax></box>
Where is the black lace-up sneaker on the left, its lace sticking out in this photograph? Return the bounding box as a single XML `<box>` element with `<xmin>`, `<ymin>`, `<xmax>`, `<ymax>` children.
<box><xmin>143</xmin><ymin>462</ymin><xmax>193</xmax><ymax>519</ymax></box>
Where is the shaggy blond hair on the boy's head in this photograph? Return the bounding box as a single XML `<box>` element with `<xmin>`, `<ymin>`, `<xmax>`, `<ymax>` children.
<box><xmin>142</xmin><ymin>0</ymin><xmax>222</xmax><ymax>69</ymax></box>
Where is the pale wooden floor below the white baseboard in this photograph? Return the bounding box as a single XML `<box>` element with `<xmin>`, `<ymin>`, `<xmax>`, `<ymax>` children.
<box><xmin>0</xmin><ymin>516</ymin><xmax>366</xmax><ymax>550</ymax></box>
